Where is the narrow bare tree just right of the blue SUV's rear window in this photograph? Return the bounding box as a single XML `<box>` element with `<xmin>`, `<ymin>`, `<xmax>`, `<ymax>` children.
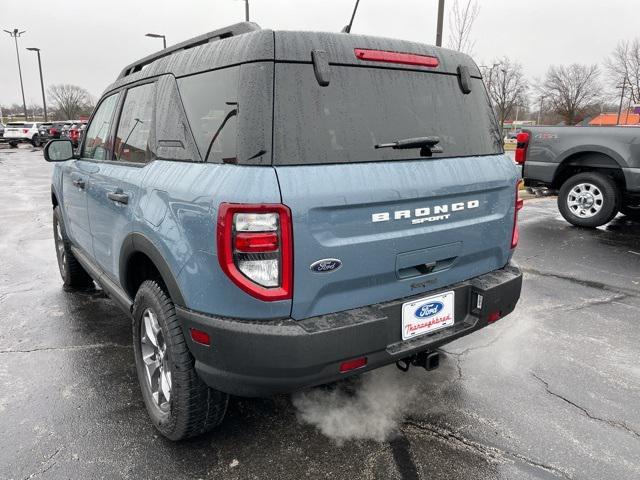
<box><xmin>484</xmin><ymin>57</ymin><xmax>529</xmax><ymax>128</ymax></box>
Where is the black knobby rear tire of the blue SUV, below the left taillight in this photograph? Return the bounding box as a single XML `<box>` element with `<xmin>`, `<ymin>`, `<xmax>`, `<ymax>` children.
<box><xmin>133</xmin><ymin>280</ymin><xmax>229</xmax><ymax>440</ymax></box>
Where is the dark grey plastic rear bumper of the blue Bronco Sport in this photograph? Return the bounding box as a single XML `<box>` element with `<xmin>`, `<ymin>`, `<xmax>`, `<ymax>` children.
<box><xmin>176</xmin><ymin>264</ymin><xmax>522</xmax><ymax>397</ymax></box>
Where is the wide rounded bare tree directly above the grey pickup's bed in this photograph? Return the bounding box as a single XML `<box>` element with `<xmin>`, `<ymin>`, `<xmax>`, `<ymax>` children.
<box><xmin>538</xmin><ymin>63</ymin><xmax>602</xmax><ymax>125</ymax></box>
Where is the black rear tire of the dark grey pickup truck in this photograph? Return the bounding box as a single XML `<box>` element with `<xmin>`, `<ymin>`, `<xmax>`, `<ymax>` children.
<box><xmin>558</xmin><ymin>172</ymin><xmax>620</xmax><ymax>228</ymax></box>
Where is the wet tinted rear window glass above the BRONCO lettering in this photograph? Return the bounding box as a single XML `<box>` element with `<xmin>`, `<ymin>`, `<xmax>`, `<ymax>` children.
<box><xmin>273</xmin><ymin>64</ymin><xmax>502</xmax><ymax>165</ymax></box>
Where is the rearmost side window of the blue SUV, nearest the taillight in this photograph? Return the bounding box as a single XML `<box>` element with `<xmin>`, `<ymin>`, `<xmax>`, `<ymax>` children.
<box><xmin>178</xmin><ymin>67</ymin><xmax>239</xmax><ymax>163</ymax></box>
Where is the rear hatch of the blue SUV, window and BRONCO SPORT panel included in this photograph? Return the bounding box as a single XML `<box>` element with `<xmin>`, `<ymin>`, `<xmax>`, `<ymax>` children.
<box><xmin>273</xmin><ymin>33</ymin><xmax>517</xmax><ymax>319</ymax></box>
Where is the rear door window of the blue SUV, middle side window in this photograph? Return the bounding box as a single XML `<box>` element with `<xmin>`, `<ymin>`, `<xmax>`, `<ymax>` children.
<box><xmin>114</xmin><ymin>83</ymin><xmax>155</xmax><ymax>163</ymax></box>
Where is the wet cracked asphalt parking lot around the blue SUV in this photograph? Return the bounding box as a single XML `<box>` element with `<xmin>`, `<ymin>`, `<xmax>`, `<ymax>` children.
<box><xmin>0</xmin><ymin>146</ymin><xmax>640</xmax><ymax>480</ymax></box>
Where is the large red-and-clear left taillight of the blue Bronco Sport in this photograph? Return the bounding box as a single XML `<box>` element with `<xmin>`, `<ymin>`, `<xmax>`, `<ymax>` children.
<box><xmin>217</xmin><ymin>203</ymin><xmax>293</xmax><ymax>301</ymax></box>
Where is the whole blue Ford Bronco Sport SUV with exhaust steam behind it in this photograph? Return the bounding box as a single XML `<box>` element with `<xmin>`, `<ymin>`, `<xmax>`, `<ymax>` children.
<box><xmin>45</xmin><ymin>23</ymin><xmax>522</xmax><ymax>440</ymax></box>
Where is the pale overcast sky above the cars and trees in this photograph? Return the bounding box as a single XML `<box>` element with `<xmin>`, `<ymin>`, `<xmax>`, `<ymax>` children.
<box><xmin>0</xmin><ymin>0</ymin><xmax>640</xmax><ymax>105</ymax></box>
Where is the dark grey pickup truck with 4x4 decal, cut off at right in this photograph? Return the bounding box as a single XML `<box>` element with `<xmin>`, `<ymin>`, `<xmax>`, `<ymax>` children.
<box><xmin>516</xmin><ymin>127</ymin><xmax>640</xmax><ymax>227</ymax></box>
